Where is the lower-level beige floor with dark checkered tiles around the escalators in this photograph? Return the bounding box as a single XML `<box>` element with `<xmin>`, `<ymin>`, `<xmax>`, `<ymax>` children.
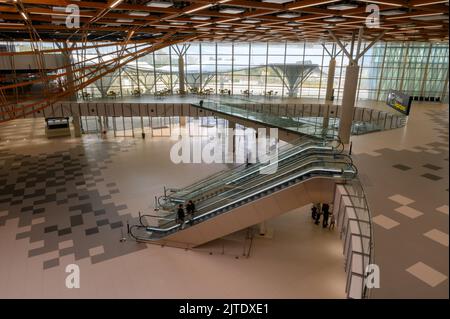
<box><xmin>0</xmin><ymin>120</ymin><xmax>346</xmax><ymax>298</ymax></box>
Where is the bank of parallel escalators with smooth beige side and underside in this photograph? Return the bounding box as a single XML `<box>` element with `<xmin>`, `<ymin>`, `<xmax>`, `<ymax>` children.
<box><xmin>129</xmin><ymin>136</ymin><xmax>357</xmax><ymax>248</ymax></box>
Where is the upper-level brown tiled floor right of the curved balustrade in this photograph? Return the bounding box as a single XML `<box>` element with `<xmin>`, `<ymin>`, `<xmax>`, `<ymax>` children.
<box><xmin>352</xmin><ymin>103</ymin><xmax>449</xmax><ymax>298</ymax></box>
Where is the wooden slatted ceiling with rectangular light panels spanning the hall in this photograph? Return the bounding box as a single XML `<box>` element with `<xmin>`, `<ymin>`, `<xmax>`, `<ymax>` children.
<box><xmin>0</xmin><ymin>0</ymin><xmax>449</xmax><ymax>42</ymax></box>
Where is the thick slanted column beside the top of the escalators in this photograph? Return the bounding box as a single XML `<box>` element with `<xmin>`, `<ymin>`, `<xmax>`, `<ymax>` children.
<box><xmin>339</xmin><ymin>64</ymin><xmax>359</xmax><ymax>144</ymax></box>
